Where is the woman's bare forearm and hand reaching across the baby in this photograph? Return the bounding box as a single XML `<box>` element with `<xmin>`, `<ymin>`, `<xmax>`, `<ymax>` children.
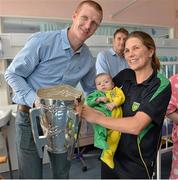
<box><xmin>81</xmin><ymin>105</ymin><xmax>151</xmax><ymax>135</ymax></box>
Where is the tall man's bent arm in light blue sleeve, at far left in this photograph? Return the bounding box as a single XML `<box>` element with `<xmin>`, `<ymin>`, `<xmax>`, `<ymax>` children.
<box><xmin>5</xmin><ymin>35</ymin><xmax>38</xmax><ymax>107</ymax></box>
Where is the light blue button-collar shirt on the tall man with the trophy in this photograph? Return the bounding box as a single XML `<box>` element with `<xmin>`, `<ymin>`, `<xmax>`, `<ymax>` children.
<box><xmin>5</xmin><ymin>28</ymin><xmax>95</xmax><ymax>107</ymax></box>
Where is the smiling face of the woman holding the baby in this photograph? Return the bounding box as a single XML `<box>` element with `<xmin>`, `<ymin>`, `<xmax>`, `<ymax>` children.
<box><xmin>124</xmin><ymin>37</ymin><xmax>154</xmax><ymax>71</ymax></box>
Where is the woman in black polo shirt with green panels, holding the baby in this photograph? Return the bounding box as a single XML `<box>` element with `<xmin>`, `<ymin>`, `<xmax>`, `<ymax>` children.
<box><xmin>81</xmin><ymin>31</ymin><xmax>171</xmax><ymax>179</ymax></box>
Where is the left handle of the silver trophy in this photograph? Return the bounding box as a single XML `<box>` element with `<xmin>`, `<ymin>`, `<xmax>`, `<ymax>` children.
<box><xmin>30</xmin><ymin>108</ymin><xmax>47</xmax><ymax>158</ymax></box>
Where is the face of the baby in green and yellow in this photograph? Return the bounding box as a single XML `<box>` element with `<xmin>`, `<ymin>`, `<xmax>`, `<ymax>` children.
<box><xmin>95</xmin><ymin>75</ymin><xmax>114</xmax><ymax>92</ymax></box>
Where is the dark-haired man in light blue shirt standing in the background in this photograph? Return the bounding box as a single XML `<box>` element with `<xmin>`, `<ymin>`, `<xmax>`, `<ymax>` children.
<box><xmin>96</xmin><ymin>28</ymin><xmax>129</xmax><ymax>77</ymax></box>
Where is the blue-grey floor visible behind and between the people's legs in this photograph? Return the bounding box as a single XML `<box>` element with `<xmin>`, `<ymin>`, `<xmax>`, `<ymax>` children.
<box><xmin>0</xmin><ymin>146</ymin><xmax>172</xmax><ymax>179</ymax></box>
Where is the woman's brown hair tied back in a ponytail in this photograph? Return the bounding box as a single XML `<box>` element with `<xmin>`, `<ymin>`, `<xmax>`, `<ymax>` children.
<box><xmin>127</xmin><ymin>31</ymin><xmax>160</xmax><ymax>70</ymax></box>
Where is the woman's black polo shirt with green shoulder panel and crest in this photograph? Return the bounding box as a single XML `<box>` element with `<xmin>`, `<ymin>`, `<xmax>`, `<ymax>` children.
<box><xmin>113</xmin><ymin>69</ymin><xmax>171</xmax><ymax>179</ymax></box>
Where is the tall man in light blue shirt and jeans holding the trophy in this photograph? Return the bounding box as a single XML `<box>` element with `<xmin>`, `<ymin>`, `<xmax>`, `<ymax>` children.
<box><xmin>5</xmin><ymin>0</ymin><xmax>103</xmax><ymax>179</ymax></box>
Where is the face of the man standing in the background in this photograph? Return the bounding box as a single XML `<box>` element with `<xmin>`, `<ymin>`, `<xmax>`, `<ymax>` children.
<box><xmin>113</xmin><ymin>32</ymin><xmax>127</xmax><ymax>55</ymax></box>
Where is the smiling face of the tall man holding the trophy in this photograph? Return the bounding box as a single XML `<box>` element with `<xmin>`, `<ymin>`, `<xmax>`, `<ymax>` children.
<box><xmin>72</xmin><ymin>4</ymin><xmax>102</xmax><ymax>43</ymax></box>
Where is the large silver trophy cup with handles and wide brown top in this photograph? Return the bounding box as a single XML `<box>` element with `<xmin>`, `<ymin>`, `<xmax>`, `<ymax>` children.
<box><xmin>30</xmin><ymin>84</ymin><xmax>83</xmax><ymax>159</ymax></box>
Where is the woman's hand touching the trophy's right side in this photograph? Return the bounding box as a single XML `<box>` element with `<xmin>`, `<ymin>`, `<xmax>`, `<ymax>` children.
<box><xmin>81</xmin><ymin>105</ymin><xmax>105</xmax><ymax>124</ymax></box>
